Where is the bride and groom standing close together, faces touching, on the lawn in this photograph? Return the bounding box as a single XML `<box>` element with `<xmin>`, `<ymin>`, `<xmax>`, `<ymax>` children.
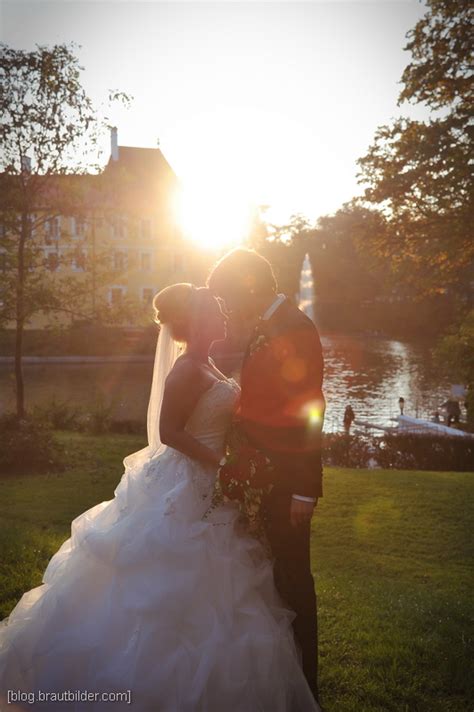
<box><xmin>0</xmin><ymin>249</ymin><xmax>325</xmax><ymax>712</ymax></box>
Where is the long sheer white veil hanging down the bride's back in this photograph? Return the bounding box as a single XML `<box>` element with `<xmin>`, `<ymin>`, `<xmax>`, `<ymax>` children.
<box><xmin>123</xmin><ymin>324</ymin><xmax>180</xmax><ymax>470</ymax></box>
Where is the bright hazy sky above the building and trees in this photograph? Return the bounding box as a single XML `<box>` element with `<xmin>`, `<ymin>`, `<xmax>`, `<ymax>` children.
<box><xmin>0</xmin><ymin>0</ymin><xmax>428</xmax><ymax>245</ymax></box>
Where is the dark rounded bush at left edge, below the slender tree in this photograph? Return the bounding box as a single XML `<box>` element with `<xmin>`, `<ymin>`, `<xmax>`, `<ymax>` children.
<box><xmin>0</xmin><ymin>413</ymin><xmax>63</xmax><ymax>475</ymax></box>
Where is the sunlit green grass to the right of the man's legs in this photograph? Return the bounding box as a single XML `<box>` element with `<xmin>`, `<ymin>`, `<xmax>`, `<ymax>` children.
<box><xmin>312</xmin><ymin>468</ymin><xmax>474</xmax><ymax>712</ymax></box>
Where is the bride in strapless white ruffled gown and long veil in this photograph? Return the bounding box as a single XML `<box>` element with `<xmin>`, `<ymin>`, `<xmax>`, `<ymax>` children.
<box><xmin>0</xmin><ymin>284</ymin><xmax>319</xmax><ymax>712</ymax></box>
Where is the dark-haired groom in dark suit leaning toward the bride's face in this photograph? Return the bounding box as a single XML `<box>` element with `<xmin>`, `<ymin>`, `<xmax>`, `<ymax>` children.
<box><xmin>207</xmin><ymin>249</ymin><xmax>326</xmax><ymax>700</ymax></box>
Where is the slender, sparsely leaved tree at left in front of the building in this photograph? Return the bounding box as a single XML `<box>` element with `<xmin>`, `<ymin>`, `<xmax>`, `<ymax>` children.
<box><xmin>0</xmin><ymin>44</ymin><xmax>133</xmax><ymax>418</ymax></box>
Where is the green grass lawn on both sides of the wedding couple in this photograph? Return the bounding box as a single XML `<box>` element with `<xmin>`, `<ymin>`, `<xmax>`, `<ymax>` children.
<box><xmin>0</xmin><ymin>433</ymin><xmax>474</xmax><ymax>712</ymax></box>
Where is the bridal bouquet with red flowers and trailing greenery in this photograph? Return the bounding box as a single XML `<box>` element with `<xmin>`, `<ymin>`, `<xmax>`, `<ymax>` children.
<box><xmin>206</xmin><ymin>420</ymin><xmax>274</xmax><ymax>545</ymax></box>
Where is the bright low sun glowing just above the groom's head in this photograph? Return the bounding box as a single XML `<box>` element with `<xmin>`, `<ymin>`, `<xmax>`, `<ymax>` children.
<box><xmin>176</xmin><ymin>175</ymin><xmax>254</xmax><ymax>250</ymax></box>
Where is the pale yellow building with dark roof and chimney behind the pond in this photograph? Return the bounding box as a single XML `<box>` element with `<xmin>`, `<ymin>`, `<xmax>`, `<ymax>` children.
<box><xmin>1</xmin><ymin>128</ymin><xmax>189</xmax><ymax>329</ymax></box>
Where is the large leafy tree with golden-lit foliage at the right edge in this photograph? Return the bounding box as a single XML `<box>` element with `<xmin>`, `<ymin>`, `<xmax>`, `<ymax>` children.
<box><xmin>358</xmin><ymin>0</ymin><xmax>474</xmax><ymax>300</ymax></box>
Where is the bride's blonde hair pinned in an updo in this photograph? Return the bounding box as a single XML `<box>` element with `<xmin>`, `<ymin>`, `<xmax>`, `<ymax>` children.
<box><xmin>153</xmin><ymin>282</ymin><xmax>198</xmax><ymax>342</ymax></box>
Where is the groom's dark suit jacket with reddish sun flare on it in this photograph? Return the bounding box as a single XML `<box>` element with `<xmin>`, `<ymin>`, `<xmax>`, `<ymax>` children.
<box><xmin>239</xmin><ymin>299</ymin><xmax>326</xmax><ymax>497</ymax></box>
